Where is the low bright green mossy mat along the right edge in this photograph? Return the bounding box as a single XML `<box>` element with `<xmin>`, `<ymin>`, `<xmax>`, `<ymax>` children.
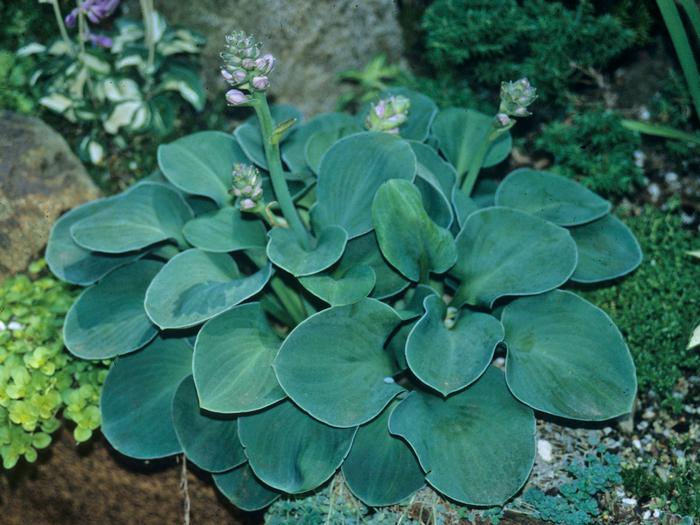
<box><xmin>584</xmin><ymin>207</ymin><xmax>700</xmax><ymax>410</ymax></box>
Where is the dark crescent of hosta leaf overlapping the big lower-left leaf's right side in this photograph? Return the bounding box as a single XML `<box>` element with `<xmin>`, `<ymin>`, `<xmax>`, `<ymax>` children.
<box><xmin>172</xmin><ymin>376</ymin><xmax>246</xmax><ymax>472</ymax></box>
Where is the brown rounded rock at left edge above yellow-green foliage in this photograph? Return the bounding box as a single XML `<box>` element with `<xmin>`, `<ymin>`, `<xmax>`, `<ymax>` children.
<box><xmin>0</xmin><ymin>111</ymin><xmax>99</xmax><ymax>280</ymax></box>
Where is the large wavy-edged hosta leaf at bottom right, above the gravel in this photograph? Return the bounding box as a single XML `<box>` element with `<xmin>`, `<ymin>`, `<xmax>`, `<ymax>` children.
<box><xmin>389</xmin><ymin>367</ymin><xmax>535</xmax><ymax>506</ymax></box>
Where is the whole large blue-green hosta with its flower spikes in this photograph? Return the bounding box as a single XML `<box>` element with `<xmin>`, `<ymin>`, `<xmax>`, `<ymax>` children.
<box><xmin>47</xmin><ymin>29</ymin><xmax>641</xmax><ymax>509</ymax></box>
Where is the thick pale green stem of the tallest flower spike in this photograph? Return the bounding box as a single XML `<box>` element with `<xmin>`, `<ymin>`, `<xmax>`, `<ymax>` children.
<box><xmin>253</xmin><ymin>91</ymin><xmax>310</xmax><ymax>247</ymax></box>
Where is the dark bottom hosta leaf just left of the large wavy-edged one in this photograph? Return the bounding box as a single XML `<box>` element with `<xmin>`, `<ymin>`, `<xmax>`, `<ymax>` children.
<box><xmin>343</xmin><ymin>402</ymin><xmax>425</xmax><ymax>507</ymax></box>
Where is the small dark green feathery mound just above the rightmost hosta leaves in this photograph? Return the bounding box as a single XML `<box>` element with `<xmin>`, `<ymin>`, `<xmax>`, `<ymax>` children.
<box><xmin>535</xmin><ymin>109</ymin><xmax>643</xmax><ymax>196</ymax></box>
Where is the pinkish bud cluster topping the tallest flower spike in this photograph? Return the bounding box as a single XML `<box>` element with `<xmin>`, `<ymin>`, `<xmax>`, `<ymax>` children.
<box><xmin>221</xmin><ymin>31</ymin><xmax>275</xmax><ymax>106</ymax></box>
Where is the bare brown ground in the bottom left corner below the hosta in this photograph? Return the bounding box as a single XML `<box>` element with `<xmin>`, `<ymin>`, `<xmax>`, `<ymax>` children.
<box><xmin>0</xmin><ymin>431</ymin><xmax>263</xmax><ymax>525</ymax></box>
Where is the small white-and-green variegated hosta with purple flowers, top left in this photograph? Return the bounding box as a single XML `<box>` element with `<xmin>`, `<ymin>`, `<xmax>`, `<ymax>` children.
<box><xmin>17</xmin><ymin>0</ymin><xmax>206</xmax><ymax>164</ymax></box>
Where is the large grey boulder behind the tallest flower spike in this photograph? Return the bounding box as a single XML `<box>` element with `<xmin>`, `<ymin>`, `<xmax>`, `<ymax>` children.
<box><xmin>127</xmin><ymin>0</ymin><xmax>403</xmax><ymax>116</ymax></box>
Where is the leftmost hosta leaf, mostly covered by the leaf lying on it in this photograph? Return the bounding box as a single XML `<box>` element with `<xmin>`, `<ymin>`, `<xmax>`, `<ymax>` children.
<box><xmin>46</xmin><ymin>198</ymin><xmax>143</xmax><ymax>286</ymax></box>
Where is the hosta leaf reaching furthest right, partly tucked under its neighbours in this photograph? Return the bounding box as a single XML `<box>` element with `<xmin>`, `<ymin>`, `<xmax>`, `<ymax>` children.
<box><xmin>570</xmin><ymin>215</ymin><xmax>642</xmax><ymax>283</ymax></box>
